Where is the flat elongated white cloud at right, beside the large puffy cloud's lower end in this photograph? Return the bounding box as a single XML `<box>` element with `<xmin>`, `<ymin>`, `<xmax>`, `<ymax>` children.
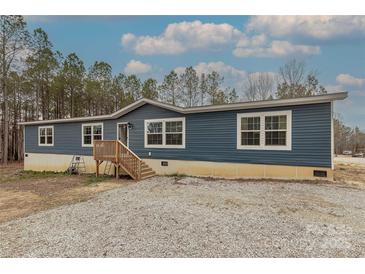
<box><xmin>233</xmin><ymin>40</ymin><xmax>320</xmax><ymax>57</ymax></box>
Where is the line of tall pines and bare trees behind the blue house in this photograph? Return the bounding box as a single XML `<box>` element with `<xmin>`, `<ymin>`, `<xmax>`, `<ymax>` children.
<box><xmin>0</xmin><ymin>16</ymin><xmax>358</xmax><ymax>163</ymax></box>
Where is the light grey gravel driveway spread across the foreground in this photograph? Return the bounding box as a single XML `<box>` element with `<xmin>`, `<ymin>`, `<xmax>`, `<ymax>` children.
<box><xmin>0</xmin><ymin>177</ymin><xmax>365</xmax><ymax>257</ymax></box>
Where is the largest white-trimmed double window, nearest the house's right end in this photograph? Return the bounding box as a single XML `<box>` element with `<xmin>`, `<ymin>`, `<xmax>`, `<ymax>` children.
<box><xmin>237</xmin><ymin>110</ymin><xmax>291</xmax><ymax>150</ymax></box>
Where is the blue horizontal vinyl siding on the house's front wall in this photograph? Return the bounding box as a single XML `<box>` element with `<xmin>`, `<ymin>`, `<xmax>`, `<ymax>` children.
<box><xmin>25</xmin><ymin>103</ymin><xmax>331</xmax><ymax>167</ymax></box>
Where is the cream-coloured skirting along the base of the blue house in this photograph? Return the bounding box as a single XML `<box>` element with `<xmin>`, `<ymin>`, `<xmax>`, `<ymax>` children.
<box><xmin>24</xmin><ymin>153</ymin><xmax>333</xmax><ymax>180</ymax></box>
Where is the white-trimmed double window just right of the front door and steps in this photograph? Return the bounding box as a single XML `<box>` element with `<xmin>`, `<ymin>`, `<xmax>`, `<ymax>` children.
<box><xmin>145</xmin><ymin>118</ymin><xmax>185</xmax><ymax>148</ymax></box>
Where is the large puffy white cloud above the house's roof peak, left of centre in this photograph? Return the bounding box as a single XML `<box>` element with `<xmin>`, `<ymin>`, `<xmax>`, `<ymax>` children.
<box><xmin>121</xmin><ymin>21</ymin><xmax>243</xmax><ymax>55</ymax></box>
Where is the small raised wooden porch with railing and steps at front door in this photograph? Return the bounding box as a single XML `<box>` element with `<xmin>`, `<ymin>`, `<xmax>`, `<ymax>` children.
<box><xmin>93</xmin><ymin>140</ymin><xmax>156</xmax><ymax>181</ymax></box>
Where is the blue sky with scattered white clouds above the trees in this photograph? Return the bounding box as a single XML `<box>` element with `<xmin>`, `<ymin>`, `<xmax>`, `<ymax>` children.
<box><xmin>26</xmin><ymin>16</ymin><xmax>365</xmax><ymax>130</ymax></box>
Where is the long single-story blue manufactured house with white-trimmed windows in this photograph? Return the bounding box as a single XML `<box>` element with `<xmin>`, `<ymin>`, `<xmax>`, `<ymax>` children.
<box><xmin>22</xmin><ymin>92</ymin><xmax>347</xmax><ymax>179</ymax></box>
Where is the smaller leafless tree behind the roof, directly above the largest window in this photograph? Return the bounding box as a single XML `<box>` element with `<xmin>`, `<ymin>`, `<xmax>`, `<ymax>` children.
<box><xmin>244</xmin><ymin>72</ymin><xmax>275</xmax><ymax>101</ymax></box>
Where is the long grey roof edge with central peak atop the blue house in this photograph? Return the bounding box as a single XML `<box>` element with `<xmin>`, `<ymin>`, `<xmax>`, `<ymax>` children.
<box><xmin>19</xmin><ymin>92</ymin><xmax>347</xmax><ymax>125</ymax></box>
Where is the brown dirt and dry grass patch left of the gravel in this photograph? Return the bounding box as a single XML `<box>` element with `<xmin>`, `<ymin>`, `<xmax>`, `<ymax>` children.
<box><xmin>0</xmin><ymin>163</ymin><xmax>132</xmax><ymax>223</ymax></box>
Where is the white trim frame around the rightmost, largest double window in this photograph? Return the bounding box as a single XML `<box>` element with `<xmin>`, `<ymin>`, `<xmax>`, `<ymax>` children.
<box><xmin>237</xmin><ymin>110</ymin><xmax>292</xmax><ymax>150</ymax></box>
